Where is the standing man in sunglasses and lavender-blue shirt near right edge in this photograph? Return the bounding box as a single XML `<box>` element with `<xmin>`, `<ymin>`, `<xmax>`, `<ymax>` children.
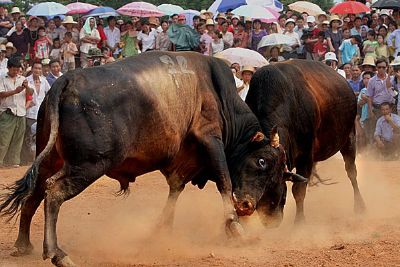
<box><xmin>367</xmin><ymin>59</ymin><xmax>394</xmax><ymax>118</ymax></box>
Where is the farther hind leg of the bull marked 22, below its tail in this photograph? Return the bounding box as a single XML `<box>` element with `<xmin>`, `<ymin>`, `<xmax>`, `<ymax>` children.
<box><xmin>11</xmin><ymin>189</ymin><xmax>44</xmax><ymax>257</ymax></box>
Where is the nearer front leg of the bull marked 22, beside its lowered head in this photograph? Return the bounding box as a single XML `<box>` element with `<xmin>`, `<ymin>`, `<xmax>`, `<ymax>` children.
<box><xmin>203</xmin><ymin>137</ymin><xmax>244</xmax><ymax>237</ymax></box>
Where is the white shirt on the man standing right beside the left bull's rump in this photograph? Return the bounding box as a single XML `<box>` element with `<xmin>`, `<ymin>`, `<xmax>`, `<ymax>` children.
<box><xmin>26</xmin><ymin>75</ymin><xmax>50</xmax><ymax>120</ymax></box>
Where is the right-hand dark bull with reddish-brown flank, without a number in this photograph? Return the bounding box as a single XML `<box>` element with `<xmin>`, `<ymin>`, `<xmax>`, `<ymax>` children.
<box><xmin>233</xmin><ymin>60</ymin><xmax>365</xmax><ymax>226</ymax></box>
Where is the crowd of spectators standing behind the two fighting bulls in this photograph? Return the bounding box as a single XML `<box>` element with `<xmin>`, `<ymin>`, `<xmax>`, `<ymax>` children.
<box><xmin>0</xmin><ymin>6</ymin><xmax>400</xmax><ymax>167</ymax></box>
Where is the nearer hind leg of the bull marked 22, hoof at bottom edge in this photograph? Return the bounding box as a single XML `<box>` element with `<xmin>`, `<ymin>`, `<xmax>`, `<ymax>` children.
<box><xmin>43</xmin><ymin>164</ymin><xmax>104</xmax><ymax>267</ymax></box>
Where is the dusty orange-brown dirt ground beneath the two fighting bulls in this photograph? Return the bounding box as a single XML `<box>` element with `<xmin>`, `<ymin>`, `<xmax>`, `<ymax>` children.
<box><xmin>0</xmin><ymin>156</ymin><xmax>400</xmax><ymax>267</ymax></box>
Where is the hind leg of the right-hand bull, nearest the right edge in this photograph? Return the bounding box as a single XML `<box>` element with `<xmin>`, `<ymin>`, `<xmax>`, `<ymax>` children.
<box><xmin>340</xmin><ymin>133</ymin><xmax>365</xmax><ymax>213</ymax></box>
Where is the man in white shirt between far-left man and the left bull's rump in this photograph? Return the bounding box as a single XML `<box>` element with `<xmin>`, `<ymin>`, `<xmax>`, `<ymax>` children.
<box><xmin>21</xmin><ymin>62</ymin><xmax>50</xmax><ymax>165</ymax></box>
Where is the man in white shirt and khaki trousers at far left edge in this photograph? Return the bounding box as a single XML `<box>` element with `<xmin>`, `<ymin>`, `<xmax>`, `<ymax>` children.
<box><xmin>0</xmin><ymin>58</ymin><xmax>33</xmax><ymax>167</ymax></box>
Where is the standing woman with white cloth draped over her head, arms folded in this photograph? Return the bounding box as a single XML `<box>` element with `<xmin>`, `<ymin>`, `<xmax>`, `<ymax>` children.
<box><xmin>79</xmin><ymin>17</ymin><xmax>100</xmax><ymax>68</ymax></box>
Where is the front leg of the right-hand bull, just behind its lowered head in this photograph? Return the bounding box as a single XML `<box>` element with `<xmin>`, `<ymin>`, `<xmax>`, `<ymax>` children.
<box><xmin>292</xmin><ymin>159</ymin><xmax>313</xmax><ymax>223</ymax></box>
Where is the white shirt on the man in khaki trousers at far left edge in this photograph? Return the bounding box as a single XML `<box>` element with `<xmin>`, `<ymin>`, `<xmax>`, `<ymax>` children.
<box><xmin>0</xmin><ymin>74</ymin><xmax>26</xmax><ymax>117</ymax></box>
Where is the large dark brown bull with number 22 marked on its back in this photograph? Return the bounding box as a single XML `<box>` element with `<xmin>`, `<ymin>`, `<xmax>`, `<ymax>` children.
<box><xmin>0</xmin><ymin>52</ymin><xmax>304</xmax><ymax>266</ymax></box>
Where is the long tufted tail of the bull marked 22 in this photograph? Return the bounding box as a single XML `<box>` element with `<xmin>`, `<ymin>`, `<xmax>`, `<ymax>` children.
<box><xmin>0</xmin><ymin>77</ymin><xmax>67</xmax><ymax>221</ymax></box>
